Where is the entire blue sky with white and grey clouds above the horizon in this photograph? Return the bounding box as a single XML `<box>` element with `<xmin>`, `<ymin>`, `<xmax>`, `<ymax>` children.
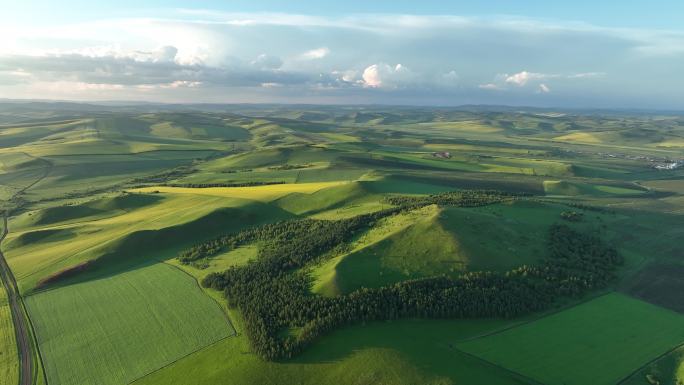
<box><xmin>0</xmin><ymin>0</ymin><xmax>684</xmax><ymax>110</ymax></box>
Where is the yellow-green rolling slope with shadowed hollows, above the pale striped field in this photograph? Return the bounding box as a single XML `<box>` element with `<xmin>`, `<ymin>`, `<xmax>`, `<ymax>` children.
<box><xmin>4</xmin><ymin>194</ymin><xmax>288</xmax><ymax>290</ymax></box>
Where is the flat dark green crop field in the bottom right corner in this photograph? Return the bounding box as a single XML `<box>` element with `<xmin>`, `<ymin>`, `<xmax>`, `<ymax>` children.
<box><xmin>458</xmin><ymin>294</ymin><xmax>684</xmax><ymax>385</ymax></box>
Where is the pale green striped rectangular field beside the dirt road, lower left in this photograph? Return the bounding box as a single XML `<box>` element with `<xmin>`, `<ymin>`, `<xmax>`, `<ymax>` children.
<box><xmin>26</xmin><ymin>264</ymin><xmax>234</xmax><ymax>385</ymax></box>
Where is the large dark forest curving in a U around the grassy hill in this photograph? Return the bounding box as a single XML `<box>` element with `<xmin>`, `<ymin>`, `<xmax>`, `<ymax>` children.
<box><xmin>202</xmin><ymin>219</ymin><xmax>622</xmax><ymax>360</ymax></box>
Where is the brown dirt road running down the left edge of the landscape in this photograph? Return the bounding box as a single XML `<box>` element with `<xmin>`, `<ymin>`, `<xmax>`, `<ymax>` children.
<box><xmin>0</xmin><ymin>213</ymin><xmax>36</xmax><ymax>385</ymax></box>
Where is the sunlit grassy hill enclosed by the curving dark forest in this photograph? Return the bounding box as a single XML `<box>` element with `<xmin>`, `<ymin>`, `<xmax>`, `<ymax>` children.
<box><xmin>313</xmin><ymin>198</ymin><xmax>563</xmax><ymax>295</ymax></box>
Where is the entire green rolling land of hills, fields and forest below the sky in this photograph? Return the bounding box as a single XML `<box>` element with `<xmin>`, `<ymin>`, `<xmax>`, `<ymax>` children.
<box><xmin>0</xmin><ymin>103</ymin><xmax>684</xmax><ymax>385</ymax></box>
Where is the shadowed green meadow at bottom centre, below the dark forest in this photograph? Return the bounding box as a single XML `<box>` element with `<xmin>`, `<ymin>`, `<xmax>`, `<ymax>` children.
<box><xmin>134</xmin><ymin>320</ymin><xmax>525</xmax><ymax>385</ymax></box>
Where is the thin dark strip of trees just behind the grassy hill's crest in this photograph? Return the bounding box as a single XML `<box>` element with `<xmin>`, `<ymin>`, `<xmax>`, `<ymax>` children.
<box><xmin>385</xmin><ymin>190</ymin><xmax>524</xmax><ymax>207</ymax></box>
